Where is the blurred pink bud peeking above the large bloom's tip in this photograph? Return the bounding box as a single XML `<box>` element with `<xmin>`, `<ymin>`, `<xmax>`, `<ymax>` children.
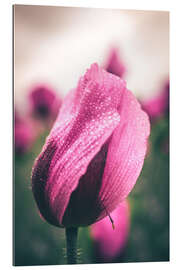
<box><xmin>104</xmin><ymin>48</ymin><xmax>126</xmax><ymax>78</ymax></box>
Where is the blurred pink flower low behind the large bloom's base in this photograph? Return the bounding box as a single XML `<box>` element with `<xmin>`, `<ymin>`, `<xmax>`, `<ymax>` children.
<box><xmin>90</xmin><ymin>200</ymin><xmax>130</xmax><ymax>261</ymax></box>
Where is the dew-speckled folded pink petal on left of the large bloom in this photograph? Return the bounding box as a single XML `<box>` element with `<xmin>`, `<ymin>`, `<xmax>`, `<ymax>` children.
<box><xmin>32</xmin><ymin>64</ymin><xmax>125</xmax><ymax>226</ymax></box>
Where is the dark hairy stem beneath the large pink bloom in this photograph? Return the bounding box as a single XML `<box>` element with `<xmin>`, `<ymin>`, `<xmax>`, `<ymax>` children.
<box><xmin>66</xmin><ymin>227</ymin><xmax>78</xmax><ymax>264</ymax></box>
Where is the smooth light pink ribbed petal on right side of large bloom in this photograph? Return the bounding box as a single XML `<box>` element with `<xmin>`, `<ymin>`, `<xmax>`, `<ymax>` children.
<box><xmin>99</xmin><ymin>87</ymin><xmax>150</xmax><ymax>218</ymax></box>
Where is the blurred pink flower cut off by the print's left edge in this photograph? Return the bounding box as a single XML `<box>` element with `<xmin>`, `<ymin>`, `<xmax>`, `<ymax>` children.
<box><xmin>14</xmin><ymin>110</ymin><xmax>36</xmax><ymax>154</ymax></box>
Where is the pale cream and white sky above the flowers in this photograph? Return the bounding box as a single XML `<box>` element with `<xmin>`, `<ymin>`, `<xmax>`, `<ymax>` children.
<box><xmin>14</xmin><ymin>5</ymin><xmax>169</xmax><ymax>108</ymax></box>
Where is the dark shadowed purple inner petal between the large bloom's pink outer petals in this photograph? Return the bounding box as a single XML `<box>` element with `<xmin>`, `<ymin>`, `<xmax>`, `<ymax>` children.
<box><xmin>63</xmin><ymin>139</ymin><xmax>109</xmax><ymax>226</ymax></box>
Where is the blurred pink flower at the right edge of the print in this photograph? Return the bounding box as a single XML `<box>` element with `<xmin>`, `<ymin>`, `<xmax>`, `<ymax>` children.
<box><xmin>141</xmin><ymin>81</ymin><xmax>169</xmax><ymax>120</ymax></box>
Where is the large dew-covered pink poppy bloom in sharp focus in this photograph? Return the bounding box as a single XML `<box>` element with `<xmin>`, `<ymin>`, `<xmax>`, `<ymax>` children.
<box><xmin>32</xmin><ymin>64</ymin><xmax>150</xmax><ymax>227</ymax></box>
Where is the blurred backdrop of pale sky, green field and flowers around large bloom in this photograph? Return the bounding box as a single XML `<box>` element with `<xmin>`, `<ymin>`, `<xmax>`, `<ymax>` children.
<box><xmin>14</xmin><ymin>5</ymin><xmax>169</xmax><ymax>265</ymax></box>
